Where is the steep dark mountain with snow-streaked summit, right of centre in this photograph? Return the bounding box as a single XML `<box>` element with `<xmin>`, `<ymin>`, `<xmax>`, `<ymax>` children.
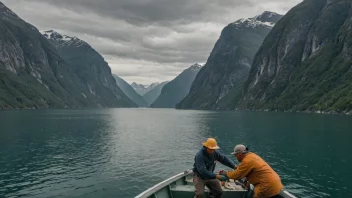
<box><xmin>176</xmin><ymin>11</ymin><xmax>282</xmax><ymax>109</ymax></box>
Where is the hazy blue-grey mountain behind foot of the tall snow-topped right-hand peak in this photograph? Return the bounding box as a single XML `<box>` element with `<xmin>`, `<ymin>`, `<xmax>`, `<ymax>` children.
<box><xmin>151</xmin><ymin>64</ymin><xmax>202</xmax><ymax>108</ymax></box>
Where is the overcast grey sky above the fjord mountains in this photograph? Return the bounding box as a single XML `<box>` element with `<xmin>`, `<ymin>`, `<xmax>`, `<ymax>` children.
<box><xmin>0</xmin><ymin>0</ymin><xmax>301</xmax><ymax>84</ymax></box>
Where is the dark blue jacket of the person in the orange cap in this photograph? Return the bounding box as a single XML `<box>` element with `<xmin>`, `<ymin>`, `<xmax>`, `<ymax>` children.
<box><xmin>193</xmin><ymin>147</ymin><xmax>235</xmax><ymax>179</ymax></box>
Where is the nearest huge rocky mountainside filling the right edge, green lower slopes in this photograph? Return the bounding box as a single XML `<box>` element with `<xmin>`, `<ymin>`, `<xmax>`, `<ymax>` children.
<box><xmin>238</xmin><ymin>0</ymin><xmax>352</xmax><ymax>113</ymax></box>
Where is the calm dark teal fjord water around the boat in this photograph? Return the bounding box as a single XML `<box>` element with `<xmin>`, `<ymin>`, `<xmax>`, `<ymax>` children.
<box><xmin>0</xmin><ymin>109</ymin><xmax>352</xmax><ymax>197</ymax></box>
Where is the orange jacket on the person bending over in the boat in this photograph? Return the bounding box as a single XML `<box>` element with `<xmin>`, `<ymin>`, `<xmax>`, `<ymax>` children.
<box><xmin>227</xmin><ymin>153</ymin><xmax>283</xmax><ymax>198</ymax></box>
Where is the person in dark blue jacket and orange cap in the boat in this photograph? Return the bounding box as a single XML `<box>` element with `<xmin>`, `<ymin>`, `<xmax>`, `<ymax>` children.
<box><xmin>193</xmin><ymin>138</ymin><xmax>236</xmax><ymax>198</ymax></box>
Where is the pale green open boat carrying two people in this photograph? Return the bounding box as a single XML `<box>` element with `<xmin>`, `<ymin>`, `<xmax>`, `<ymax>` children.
<box><xmin>135</xmin><ymin>170</ymin><xmax>296</xmax><ymax>198</ymax></box>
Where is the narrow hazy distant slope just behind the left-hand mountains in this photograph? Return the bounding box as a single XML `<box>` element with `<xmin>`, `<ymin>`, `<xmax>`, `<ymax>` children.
<box><xmin>113</xmin><ymin>75</ymin><xmax>149</xmax><ymax>107</ymax></box>
